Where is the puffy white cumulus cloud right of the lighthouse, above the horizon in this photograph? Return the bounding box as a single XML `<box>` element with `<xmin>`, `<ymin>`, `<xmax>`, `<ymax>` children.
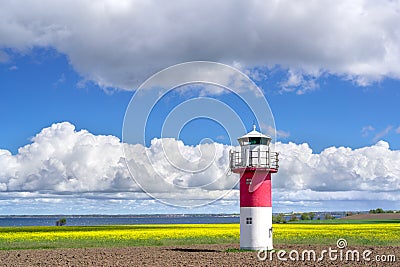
<box><xmin>273</xmin><ymin>141</ymin><xmax>400</xmax><ymax>200</ymax></box>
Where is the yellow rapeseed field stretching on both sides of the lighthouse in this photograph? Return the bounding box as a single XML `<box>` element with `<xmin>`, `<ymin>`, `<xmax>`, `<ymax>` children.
<box><xmin>0</xmin><ymin>223</ymin><xmax>400</xmax><ymax>249</ymax></box>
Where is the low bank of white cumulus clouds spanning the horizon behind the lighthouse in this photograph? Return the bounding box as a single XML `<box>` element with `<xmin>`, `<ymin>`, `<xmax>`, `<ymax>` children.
<box><xmin>0</xmin><ymin>122</ymin><xmax>400</xmax><ymax>213</ymax></box>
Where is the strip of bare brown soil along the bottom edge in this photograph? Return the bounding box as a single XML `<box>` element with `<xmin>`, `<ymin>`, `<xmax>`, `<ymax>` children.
<box><xmin>0</xmin><ymin>244</ymin><xmax>400</xmax><ymax>267</ymax></box>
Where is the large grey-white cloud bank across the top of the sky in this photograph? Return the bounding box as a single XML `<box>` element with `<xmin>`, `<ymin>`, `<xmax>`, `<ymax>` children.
<box><xmin>0</xmin><ymin>0</ymin><xmax>400</xmax><ymax>93</ymax></box>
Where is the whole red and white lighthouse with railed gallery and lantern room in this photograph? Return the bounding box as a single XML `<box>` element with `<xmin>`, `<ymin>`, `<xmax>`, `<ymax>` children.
<box><xmin>230</xmin><ymin>125</ymin><xmax>279</xmax><ymax>250</ymax></box>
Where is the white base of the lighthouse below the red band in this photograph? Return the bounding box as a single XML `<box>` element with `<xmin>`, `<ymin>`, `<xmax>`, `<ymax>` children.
<box><xmin>240</xmin><ymin>207</ymin><xmax>273</xmax><ymax>250</ymax></box>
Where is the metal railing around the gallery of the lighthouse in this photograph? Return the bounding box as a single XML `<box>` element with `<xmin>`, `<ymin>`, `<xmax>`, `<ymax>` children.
<box><xmin>229</xmin><ymin>150</ymin><xmax>279</xmax><ymax>169</ymax></box>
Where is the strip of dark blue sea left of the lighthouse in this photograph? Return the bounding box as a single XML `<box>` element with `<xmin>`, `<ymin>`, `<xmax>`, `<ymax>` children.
<box><xmin>0</xmin><ymin>214</ymin><xmax>240</xmax><ymax>227</ymax></box>
